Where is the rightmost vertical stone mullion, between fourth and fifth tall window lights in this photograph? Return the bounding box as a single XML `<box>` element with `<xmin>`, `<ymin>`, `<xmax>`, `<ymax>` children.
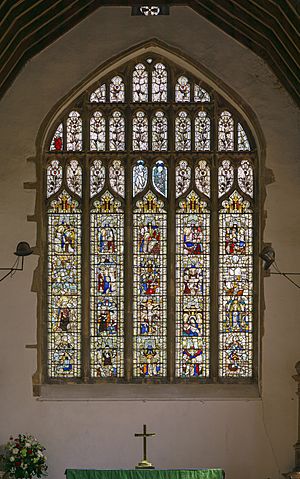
<box><xmin>210</xmin><ymin>99</ymin><xmax>219</xmax><ymax>382</ymax></box>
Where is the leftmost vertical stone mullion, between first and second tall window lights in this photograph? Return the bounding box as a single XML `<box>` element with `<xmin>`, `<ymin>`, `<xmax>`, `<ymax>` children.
<box><xmin>81</xmin><ymin>151</ymin><xmax>91</xmax><ymax>382</ymax></box>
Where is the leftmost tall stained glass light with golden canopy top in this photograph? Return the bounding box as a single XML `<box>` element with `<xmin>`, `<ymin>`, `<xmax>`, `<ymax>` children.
<box><xmin>48</xmin><ymin>191</ymin><xmax>81</xmax><ymax>378</ymax></box>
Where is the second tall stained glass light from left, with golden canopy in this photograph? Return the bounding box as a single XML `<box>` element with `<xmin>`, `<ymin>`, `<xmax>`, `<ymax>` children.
<box><xmin>90</xmin><ymin>191</ymin><xmax>124</xmax><ymax>378</ymax></box>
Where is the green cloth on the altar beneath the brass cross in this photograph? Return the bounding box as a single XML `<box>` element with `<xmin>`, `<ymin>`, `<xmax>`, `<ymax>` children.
<box><xmin>65</xmin><ymin>469</ymin><xmax>225</xmax><ymax>479</ymax></box>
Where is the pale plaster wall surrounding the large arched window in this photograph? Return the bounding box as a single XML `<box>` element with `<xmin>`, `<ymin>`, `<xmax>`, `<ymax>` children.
<box><xmin>0</xmin><ymin>7</ymin><xmax>300</xmax><ymax>479</ymax></box>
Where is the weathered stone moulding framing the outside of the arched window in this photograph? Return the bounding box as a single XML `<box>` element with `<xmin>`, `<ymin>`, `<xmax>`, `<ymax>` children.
<box><xmin>30</xmin><ymin>39</ymin><xmax>268</xmax><ymax>400</ymax></box>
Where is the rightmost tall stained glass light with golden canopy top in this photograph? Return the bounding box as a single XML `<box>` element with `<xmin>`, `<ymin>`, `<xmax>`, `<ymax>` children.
<box><xmin>219</xmin><ymin>191</ymin><xmax>253</xmax><ymax>378</ymax></box>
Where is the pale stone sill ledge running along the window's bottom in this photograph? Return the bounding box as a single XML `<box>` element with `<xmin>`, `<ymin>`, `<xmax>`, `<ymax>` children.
<box><xmin>37</xmin><ymin>384</ymin><xmax>261</xmax><ymax>402</ymax></box>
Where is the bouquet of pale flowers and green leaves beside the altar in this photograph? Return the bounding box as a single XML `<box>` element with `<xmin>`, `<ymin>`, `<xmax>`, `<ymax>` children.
<box><xmin>1</xmin><ymin>434</ymin><xmax>48</xmax><ymax>479</ymax></box>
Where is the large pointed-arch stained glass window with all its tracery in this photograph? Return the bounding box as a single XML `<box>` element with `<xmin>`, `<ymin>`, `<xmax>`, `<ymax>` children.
<box><xmin>44</xmin><ymin>54</ymin><xmax>257</xmax><ymax>383</ymax></box>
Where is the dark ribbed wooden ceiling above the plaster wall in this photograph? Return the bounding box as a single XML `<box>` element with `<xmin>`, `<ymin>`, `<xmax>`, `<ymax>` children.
<box><xmin>0</xmin><ymin>0</ymin><xmax>300</xmax><ymax>105</ymax></box>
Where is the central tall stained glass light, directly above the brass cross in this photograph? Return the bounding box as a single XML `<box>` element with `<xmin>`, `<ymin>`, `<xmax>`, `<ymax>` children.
<box><xmin>133</xmin><ymin>191</ymin><xmax>167</xmax><ymax>378</ymax></box>
